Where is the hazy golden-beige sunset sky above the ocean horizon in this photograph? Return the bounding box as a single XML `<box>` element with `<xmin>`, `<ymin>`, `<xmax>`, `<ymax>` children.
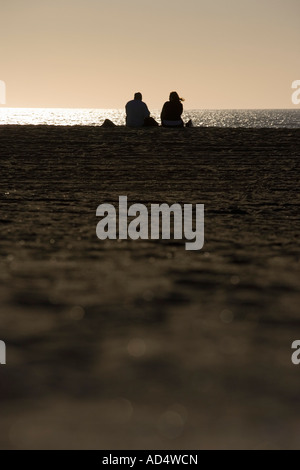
<box><xmin>0</xmin><ymin>0</ymin><xmax>300</xmax><ymax>109</ymax></box>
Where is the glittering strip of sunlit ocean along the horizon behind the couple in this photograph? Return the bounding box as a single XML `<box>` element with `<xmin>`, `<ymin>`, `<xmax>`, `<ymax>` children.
<box><xmin>0</xmin><ymin>108</ymin><xmax>300</xmax><ymax>128</ymax></box>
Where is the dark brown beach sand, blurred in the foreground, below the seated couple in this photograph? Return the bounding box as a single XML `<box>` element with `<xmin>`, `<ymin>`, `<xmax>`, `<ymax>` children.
<box><xmin>0</xmin><ymin>126</ymin><xmax>300</xmax><ymax>449</ymax></box>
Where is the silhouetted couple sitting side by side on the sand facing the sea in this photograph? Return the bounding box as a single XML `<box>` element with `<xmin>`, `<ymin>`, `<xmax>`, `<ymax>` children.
<box><xmin>125</xmin><ymin>91</ymin><xmax>184</xmax><ymax>127</ymax></box>
